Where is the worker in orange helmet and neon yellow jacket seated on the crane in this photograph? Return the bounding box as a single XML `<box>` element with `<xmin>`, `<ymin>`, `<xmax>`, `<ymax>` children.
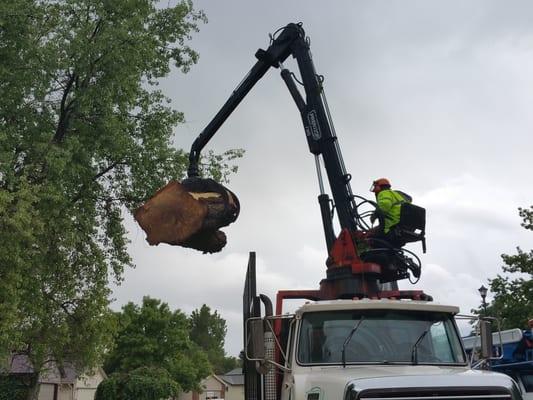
<box><xmin>368</xmin><ymin>178</ymin><xmax>412</xmax><ymax>246</ymax></box>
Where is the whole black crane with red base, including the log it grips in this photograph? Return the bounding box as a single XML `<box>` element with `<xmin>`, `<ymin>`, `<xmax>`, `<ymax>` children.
<box><xmin>135</xmin><ymin>19</ymin><xmax>425</xmax><ymax>300</ymax></box>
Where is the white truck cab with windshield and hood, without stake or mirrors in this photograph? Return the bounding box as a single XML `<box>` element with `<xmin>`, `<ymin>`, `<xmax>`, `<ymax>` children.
<box><xmin>280</xmin><ymin>299</ymin><xmax>520</xmax><ymax>400</ymax></box>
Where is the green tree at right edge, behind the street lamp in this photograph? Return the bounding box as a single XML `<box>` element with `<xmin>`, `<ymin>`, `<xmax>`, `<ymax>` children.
<box><xmin>477</xmin><ymin>206</ymin><xmax>533</xmax><ymax>329</ymax></box>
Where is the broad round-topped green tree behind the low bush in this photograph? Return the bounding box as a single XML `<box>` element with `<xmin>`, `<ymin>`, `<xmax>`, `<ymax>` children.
<box><xmin>104</xmin><ymin>297</ymin><xmax>210</xmax><ymax>391</ymax></box>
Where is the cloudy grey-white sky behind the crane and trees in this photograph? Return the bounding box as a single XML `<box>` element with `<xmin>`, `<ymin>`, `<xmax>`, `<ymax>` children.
<box><xmin>113</xmin><ymin>0</ymin><xmax>533</xmax><ymax>356</ymax></box>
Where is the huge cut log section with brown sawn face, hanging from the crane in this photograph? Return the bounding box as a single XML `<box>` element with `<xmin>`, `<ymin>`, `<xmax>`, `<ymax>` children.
<box><xmin>134</xmin><ymin>178</ymin><xmax>240</xmax><ymax>253</ymax></box>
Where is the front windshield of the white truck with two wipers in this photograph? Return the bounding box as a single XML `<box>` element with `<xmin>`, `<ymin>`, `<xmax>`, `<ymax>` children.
<box><xmin>297</xmin><ymin>310</ymin><xmax>466</xmax><ymax>365</ymax></box>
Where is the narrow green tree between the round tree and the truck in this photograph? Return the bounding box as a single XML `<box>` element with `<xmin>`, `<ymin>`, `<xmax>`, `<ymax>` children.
<box><xmin>190</xmin><ymin>304</ymin><xmax>239</xmax><ymax>374</ymax></box>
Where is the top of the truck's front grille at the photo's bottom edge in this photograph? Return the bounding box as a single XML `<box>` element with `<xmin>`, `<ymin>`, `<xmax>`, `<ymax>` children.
<box><xmin>348</xmin><ymin>387</ymin><xmax>511</xmax><ymax>400</ymax></box>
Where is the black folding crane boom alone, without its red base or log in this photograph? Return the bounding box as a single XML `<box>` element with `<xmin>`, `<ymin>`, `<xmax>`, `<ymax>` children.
<box><xmin>188</xmin><ymin>23</ymin><xmax>358</xmax><ymax>251</ymax></box>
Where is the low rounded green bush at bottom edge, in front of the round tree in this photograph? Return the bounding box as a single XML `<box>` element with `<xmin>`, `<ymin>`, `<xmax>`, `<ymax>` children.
<box><xmin>95</xmin><ymin>367</ymin><xmax>180</xmax><ymax>400</ymax></box>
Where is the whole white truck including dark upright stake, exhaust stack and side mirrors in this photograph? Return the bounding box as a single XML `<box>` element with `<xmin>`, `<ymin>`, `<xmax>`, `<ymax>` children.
<box><xmin>243</xmin><ymin>253</ymin><xmax>523</xmax><ymax>400</ymax></box>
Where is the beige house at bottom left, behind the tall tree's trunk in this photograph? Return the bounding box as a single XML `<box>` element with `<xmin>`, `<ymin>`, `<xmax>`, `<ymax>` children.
<box><xmin>5</xmin><ymin>355</ymin><xmax>106</xmax><ymax>400</ymax></box>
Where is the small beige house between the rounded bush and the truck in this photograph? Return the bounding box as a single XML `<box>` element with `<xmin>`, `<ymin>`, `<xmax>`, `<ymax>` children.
<box><xmin>178</xmin><ymin>368</ymin><xmax>244</xmax><ymax>400</ymax></box>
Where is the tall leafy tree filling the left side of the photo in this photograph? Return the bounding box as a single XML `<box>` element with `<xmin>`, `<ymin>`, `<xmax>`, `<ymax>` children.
<box><xmin>0</xmin><ymin>0</ymin><xmax>240</xmax><ymax>397</ymax></box>
